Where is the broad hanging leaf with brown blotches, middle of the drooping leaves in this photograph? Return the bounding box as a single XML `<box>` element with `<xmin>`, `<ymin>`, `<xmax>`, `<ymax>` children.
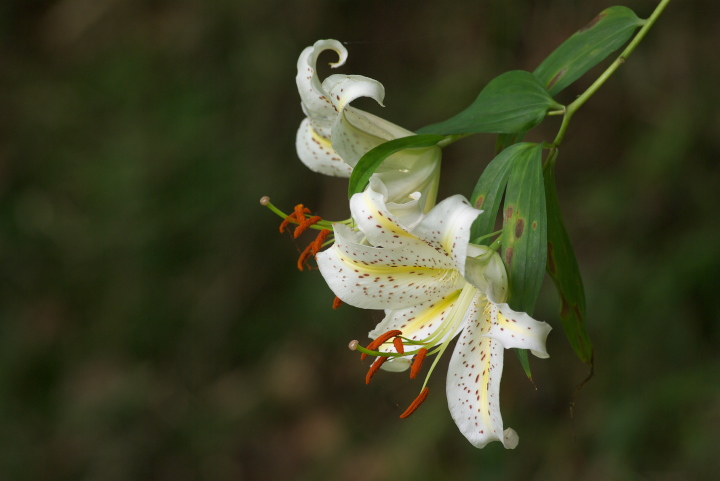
<box><xmin>501</xmin><ymin>144</ymin><xmax>547</xmax><ymax>315</ymax></box>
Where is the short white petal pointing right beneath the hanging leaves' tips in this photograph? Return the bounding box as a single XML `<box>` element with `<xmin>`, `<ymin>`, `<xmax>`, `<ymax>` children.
<box><xmin>486</xmin><ymin>297</ymin><xmax>552</xmax><ymax>359</ymax></box>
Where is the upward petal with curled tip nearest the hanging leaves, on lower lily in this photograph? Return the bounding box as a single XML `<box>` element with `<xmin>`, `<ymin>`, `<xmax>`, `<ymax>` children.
<box><xmin>412</xmin><ymin>195</ymin><xmax>482</xmax><ymax>275</ymax></box>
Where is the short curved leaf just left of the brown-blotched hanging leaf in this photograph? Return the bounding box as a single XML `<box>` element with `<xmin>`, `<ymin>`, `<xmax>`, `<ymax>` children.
<box><xmin>470</xmin><ymin>142</ymin><xmax>537</xmax><ymax>240</ymax></box>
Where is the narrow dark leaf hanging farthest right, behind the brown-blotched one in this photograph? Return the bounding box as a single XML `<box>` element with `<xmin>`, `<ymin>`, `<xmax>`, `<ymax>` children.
<box><xmin>545</xmin><ymin>155</ymin><xmax>593</xmax><ymax>365</ymax></box>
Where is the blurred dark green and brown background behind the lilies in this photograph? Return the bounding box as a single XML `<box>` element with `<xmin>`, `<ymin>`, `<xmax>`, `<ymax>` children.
<box><xmin>0</xmin><ymin>0</ymin><xmax>720</xmax><ymax>481</ymax></box>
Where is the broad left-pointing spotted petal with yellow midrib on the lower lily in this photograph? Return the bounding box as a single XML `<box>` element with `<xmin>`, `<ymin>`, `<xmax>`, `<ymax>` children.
<box><xmin>317</xmin><ymin>224</ymin><xmax>465</xmax><ymax>309</ymax></box>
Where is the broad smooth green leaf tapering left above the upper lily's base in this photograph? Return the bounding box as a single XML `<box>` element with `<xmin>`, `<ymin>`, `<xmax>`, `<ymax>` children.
<box><xmin>418</xmin><ymin>70</ymin><xmax>562</xmax><ymax>135</ymax></box>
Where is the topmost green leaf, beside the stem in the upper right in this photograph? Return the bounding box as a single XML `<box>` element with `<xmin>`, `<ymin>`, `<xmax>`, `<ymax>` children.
<box><xmin>534</xmin><ymin>6</ymin><xmax>645</xmax><ymax>95</ymax></box>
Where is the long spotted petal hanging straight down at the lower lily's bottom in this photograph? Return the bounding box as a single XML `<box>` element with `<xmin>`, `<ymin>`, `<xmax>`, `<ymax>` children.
<box><xmin>446</xmin><ymin>293</ymin><xmax>506</xmax><ymax>448</ymax></box>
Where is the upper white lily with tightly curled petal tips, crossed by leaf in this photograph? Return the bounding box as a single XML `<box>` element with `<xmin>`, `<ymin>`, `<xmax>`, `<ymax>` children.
<box><xmin>296</xmin><ymin>40</ymin><xmax>441</xmax><ymax>211</ymax></box>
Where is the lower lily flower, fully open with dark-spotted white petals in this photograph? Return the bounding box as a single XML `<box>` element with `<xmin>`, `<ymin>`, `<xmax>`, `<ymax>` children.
<box><xmin>317</xmin><ymin>179</ymin><xmax>551</xmax><ymax>449</ymax></box>
